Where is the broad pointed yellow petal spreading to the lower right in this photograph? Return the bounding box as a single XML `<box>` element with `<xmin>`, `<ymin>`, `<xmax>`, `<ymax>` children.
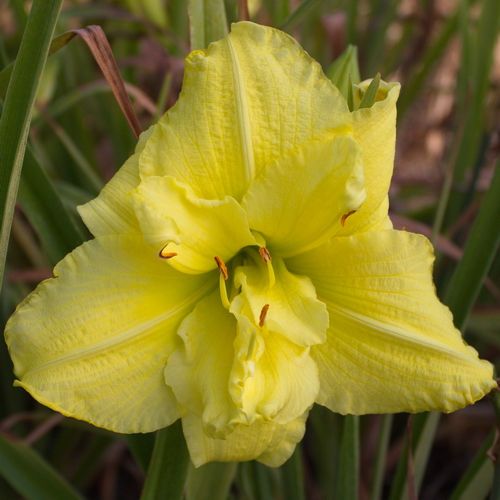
<box><xmin>288</xmin><ymin>230</ymin><xmax>496</xmax><ymax>414</ymax></box>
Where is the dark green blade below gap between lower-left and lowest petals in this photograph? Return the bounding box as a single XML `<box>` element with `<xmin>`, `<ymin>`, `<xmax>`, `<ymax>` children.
<box><xmin>141</xmin><ymin>420</ymin><xmax>189</xmax><ymax>500</ymax></box>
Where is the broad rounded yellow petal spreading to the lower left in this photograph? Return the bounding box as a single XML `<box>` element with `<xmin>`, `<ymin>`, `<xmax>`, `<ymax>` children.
<box><xmin>5</xmin><ymin>236</ymin><xmax>216</xmax><ymax>433</ymax></box>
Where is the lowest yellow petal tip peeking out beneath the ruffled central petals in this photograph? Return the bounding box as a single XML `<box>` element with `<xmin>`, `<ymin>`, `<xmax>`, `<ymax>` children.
<box><xmin>182</xmin><ymin>412</ymin><xmax>307</xmax><ymax>467</ymax></box>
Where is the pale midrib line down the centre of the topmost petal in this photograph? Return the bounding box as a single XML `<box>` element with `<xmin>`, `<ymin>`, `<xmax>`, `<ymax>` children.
<box><xmin>227</xmin><ymin>36</ymin><xmax>255</xmax><ymax>183</ymax></box>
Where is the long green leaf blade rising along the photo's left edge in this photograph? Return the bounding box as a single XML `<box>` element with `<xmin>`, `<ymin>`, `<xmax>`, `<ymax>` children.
<box><xmin>0</xmin><ymin>0</ymin><xmax>62</xmax><ymax>282</ymax></box>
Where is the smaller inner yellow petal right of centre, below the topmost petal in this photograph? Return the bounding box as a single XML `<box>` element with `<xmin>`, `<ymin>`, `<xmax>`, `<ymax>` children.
<box><xmin>242</xmin><ymin>136</ymin><xmax>365</xmax><ymax>256</ymax></box>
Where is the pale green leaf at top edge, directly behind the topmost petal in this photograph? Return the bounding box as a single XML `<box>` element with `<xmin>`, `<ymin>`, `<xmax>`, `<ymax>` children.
<box><xmin>188</xmin><ymin>0</ymin><xmax>228</xmax><ymax>50</ymax></box>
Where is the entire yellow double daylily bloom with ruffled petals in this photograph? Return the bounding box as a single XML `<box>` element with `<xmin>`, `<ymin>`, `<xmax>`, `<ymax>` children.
<box><xmin>6</xmin><ymin>22</ymin><xmax>496</xmax><ymax>466</ymax></box>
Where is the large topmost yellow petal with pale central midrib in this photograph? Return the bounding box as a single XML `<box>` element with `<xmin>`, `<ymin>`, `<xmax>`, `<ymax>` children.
<box><xmin>140</xmin><ymin>22</ymin><xmax>351</xmax><ymax>200</ymax></box>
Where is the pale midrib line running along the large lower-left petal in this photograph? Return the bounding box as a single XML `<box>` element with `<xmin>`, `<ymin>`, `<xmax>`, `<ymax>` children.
<box><xmin>24</xmin><ymin>283</ymin><xmax>213</xmax><ymax>378</ymax></box>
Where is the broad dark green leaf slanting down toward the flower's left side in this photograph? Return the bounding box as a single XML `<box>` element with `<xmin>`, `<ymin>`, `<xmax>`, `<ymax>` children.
<box><xmin>19</xmin><ymin>148</ymin><xmax>83</xmax><ymax>264</ymax></box>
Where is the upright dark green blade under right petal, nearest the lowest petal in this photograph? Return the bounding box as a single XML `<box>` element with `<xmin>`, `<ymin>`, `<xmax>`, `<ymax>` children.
<box><xmin>335</xmin><ymin>415</ymin><xmax>359</xmax><ymax>500</ymax></box>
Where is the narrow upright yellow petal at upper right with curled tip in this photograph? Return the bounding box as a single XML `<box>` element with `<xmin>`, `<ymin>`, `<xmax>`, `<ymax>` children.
<box><xmin>338</xmin><ymin>81</ymin><xmax>400</xmax><ymax>235</ymax></box>
